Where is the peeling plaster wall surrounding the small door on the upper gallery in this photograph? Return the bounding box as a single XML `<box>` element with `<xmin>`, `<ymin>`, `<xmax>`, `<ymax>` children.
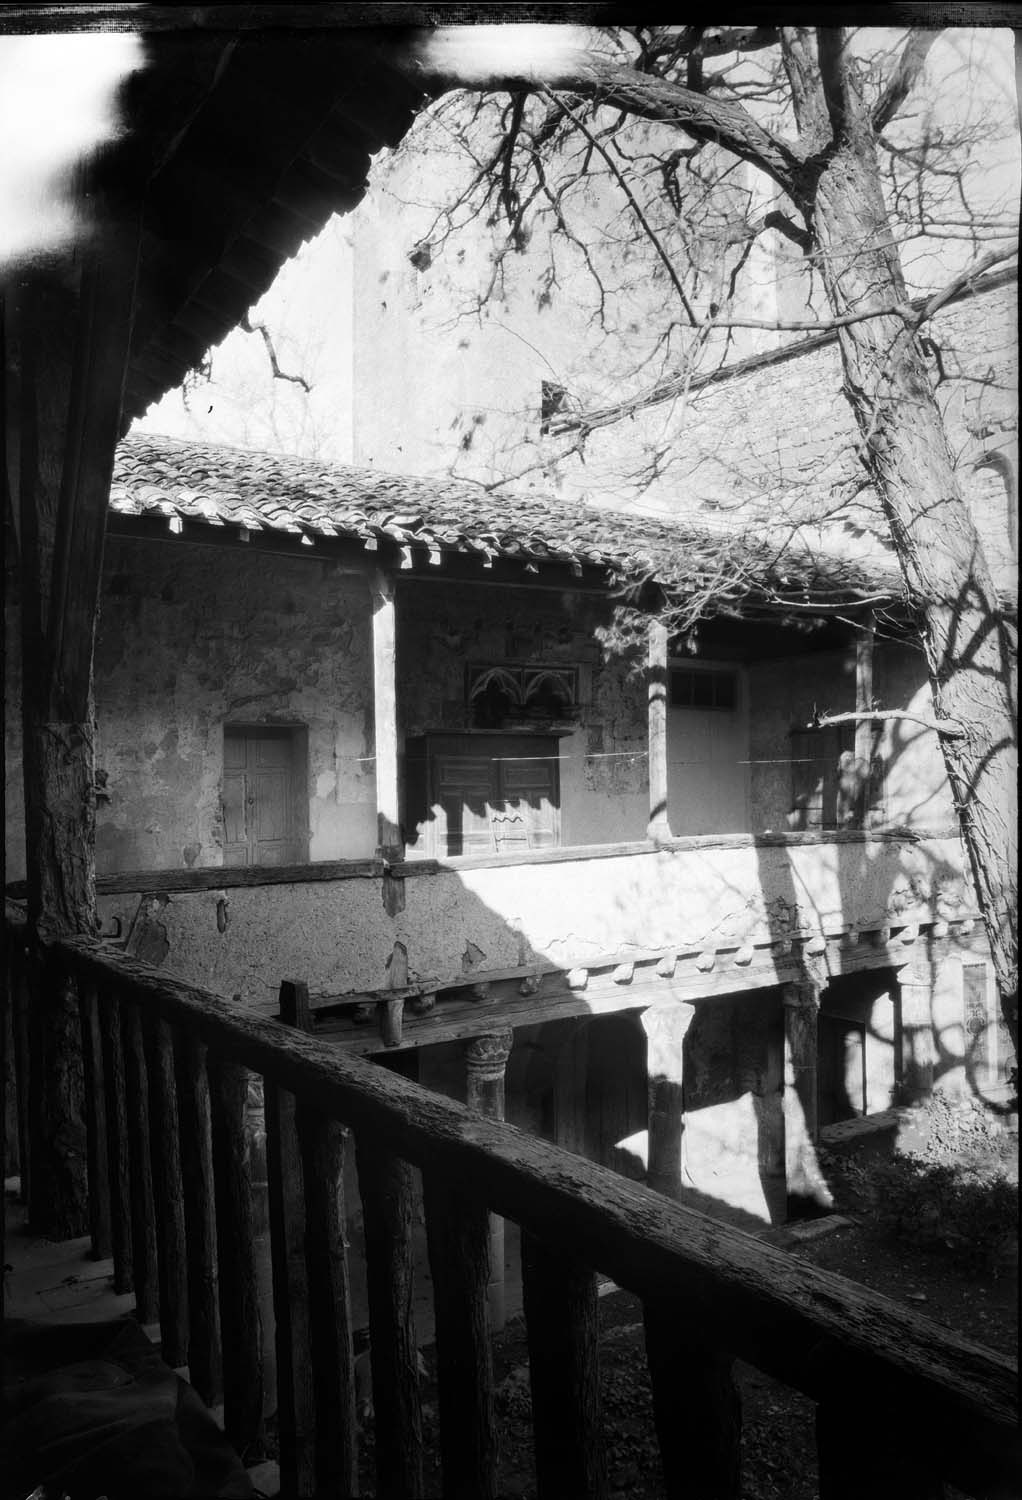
<box><xmin>8</xmin><ymin>539</ymin><xmax>377</xmax><ymax>878</ymax></box>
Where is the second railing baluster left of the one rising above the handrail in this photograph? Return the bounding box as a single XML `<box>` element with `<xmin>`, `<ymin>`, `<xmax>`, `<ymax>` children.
<box><xmin>174</xmin><ymin>1031</ymin><xmax>224</xmax><ymax>1406</ymax></box>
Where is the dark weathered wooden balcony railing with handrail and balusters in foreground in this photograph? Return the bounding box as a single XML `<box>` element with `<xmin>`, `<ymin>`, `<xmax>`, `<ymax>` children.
<box><xmin>8</xmin><ymin>900</ymin><xmax>1022</xmax><ymax>1500</ymax></box>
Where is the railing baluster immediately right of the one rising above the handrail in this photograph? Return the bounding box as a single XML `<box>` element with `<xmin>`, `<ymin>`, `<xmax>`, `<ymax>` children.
<box><xmin>297</xmin><ymin>1100</ymin><xmax>359</xmax><ymax>1496</ymax></box>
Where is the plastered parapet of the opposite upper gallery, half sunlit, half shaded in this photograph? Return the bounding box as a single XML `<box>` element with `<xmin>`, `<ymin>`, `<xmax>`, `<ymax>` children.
<box><xmin>99</xmin><ymin>839</ymin><xmax>974</xmax><ymax>1013</ymax></box>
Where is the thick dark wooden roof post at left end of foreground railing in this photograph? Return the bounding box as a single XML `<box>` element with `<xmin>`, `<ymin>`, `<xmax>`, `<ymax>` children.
<box><xmin>5</xmin><ymin>214</ymin><xmax>140</xmax><ymax>1239</ymax></box>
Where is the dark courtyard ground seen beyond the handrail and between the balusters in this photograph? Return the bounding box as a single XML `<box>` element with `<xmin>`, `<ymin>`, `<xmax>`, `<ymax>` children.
<box><xmin>363</xmin><ymin>1205</ymin><xmax>1017</xmax><ymax>1500</ymax></box>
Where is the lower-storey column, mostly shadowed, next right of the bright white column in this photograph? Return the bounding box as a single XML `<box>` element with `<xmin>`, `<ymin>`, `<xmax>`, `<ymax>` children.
<box><xmin>780</xmin><ymin>980</ymin><xmax>833</xmax><ymax>1218</ymax></box>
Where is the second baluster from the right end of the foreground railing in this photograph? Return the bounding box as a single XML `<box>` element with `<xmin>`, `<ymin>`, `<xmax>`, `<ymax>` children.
<box><xmin>642</xmin><ymin>1301</ymin><xmax>741</xmax><ymax>1500</ymax></box>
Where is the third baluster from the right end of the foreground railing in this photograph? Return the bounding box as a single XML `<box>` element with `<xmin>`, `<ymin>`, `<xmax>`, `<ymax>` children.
<box><xmin>522</xmin><ymin>1230</ymin><xmax>606</xmax><ymax>1500</ymax></box>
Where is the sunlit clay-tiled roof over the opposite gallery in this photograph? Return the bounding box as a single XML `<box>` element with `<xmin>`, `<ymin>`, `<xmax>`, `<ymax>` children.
<box><xmin>111</xmin><ymin>435</ymin><xmax>899</xmax><ymax>608</ymax></box>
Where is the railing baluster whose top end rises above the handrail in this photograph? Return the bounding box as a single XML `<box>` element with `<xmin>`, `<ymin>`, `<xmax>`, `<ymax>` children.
<box><xmin>264</xmin><ymin>981</ymin><xmax>315</xmax><ymax>1500</ymax></box>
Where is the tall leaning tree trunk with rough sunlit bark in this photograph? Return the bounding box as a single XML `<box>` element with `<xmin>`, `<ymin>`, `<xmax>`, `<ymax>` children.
<box><xmin>783</xmin><ymin>30</ymin><xmax>1017</xmax><ymax>1049</ymax></box>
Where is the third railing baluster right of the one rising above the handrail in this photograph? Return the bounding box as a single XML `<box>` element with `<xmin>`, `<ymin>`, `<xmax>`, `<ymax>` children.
<box><xmin>423</xmin><ymin>1170</ymin><xmax>500</xmax><ymax>1500</ymax></box>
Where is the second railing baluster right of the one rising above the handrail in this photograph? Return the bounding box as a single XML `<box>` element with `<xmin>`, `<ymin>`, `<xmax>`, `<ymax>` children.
<box><xmin>356</xmin><ymin>1136</ymin><xmax>423</xmax><ymax>1500</ymax></box>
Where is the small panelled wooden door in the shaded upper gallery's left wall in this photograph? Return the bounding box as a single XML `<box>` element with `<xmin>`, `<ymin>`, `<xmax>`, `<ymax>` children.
<box><xmin>222</xmin><ymin>726</ymin><xmax>308</xmax><ymax>866</ymax></box>
